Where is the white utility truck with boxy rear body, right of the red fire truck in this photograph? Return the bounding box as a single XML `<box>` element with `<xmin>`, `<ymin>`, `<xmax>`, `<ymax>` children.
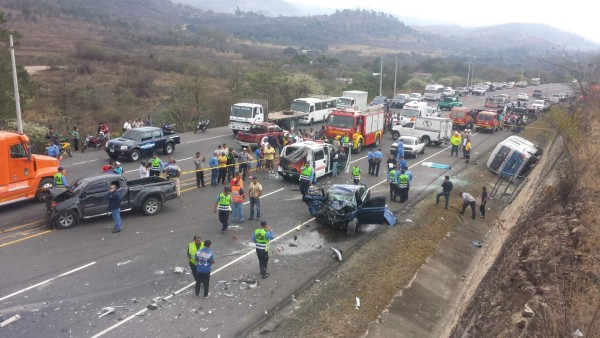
<box><xmin>392</xmin><ymin>116</ymin><xmax>452</xmax><ymax>146</ymax></box>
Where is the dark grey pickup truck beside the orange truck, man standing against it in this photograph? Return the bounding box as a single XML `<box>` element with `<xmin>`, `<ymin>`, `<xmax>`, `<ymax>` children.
<box><xmin>46</xmin><ymin>174</ymin><xmax>177</xmax><ymax>229</ymax></box>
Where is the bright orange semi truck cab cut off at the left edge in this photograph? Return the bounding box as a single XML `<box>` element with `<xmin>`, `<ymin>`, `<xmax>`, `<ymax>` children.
<box><xmin>0</xmin><ymin>131</ymin><xmax>58</xmax><ymax>206</ymax></box>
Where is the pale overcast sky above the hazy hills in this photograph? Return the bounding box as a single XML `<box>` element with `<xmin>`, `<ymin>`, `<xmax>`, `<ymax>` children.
<box><xmin>287</xmin><ymin>0</ymin><xmax>600</xmax><ymax>43</ymax></box>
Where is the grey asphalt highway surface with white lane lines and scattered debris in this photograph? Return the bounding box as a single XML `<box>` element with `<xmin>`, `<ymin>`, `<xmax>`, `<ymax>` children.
<box><xmin>0</xmin><ymin>84</ymin><xmax>567</xmax><ymax>337</ymax></box>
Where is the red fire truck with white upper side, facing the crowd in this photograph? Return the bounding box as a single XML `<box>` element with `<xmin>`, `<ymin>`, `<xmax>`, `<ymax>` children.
<box><xmin>326</xmin><ymin>108</ymin><xmax>385</xmax><ymax>152</ymax></box>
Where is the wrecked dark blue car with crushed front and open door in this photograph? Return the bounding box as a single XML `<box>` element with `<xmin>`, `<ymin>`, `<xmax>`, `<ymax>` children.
<box><xmin>302</xmin><ymin>184</ymin><xmax>396</xmax><ymax>234</ymax></box>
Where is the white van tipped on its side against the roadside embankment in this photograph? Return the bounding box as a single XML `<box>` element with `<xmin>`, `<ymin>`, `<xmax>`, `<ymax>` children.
<box><xmin>487</xmin><ymin>136</ymin><xmax>543</xmax><ymax>180</ymax></box>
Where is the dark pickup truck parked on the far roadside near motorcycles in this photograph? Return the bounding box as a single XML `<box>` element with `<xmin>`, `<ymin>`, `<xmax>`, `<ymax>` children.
<box><xmin>106</xmin><ymin>127</ymin><xmax>180</xmax><ymax>162</ymax></box>
